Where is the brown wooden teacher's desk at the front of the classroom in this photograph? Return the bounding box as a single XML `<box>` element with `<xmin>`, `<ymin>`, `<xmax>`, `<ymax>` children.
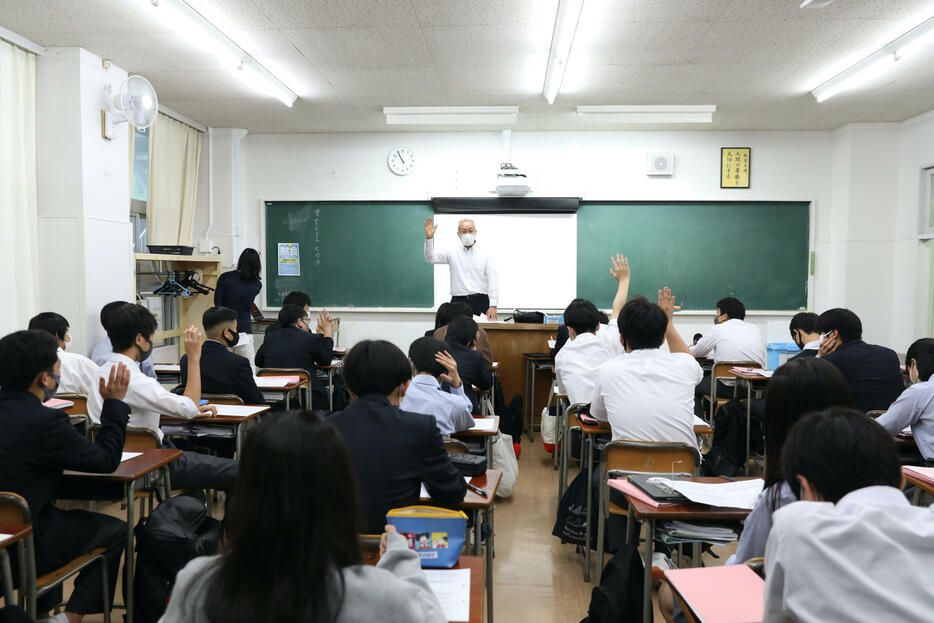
<box><xmin>480</xmin><ymin>322</ymin><xmax>558</xmax><ymax>441</ymax></box>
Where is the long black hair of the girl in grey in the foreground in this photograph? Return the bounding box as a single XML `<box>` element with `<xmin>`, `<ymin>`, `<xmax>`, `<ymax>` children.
<box><xmin>204</xmin><ymin>411</ymin><xmax>361</xmax><ymax>623</ymax></box>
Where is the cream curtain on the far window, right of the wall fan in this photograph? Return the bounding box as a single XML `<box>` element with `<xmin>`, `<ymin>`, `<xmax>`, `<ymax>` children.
<box><xmin>146</xmin><ymin>115</ymin><xmax>201</xmax><ymax>245</ymax></box>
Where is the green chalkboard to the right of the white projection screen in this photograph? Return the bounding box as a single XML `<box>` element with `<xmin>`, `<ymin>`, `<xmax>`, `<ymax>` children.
<box><xmin>577</xmin><ymin>202</ymin><xmax>809</xmax><ymax>310</ymax></box>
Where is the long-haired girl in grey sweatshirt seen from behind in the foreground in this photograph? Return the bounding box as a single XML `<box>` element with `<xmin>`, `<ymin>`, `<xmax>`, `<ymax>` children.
<box><xmin>160</xmin><ymin>411</ymin><xmax>447</xmax><ymax>623</ymax></box>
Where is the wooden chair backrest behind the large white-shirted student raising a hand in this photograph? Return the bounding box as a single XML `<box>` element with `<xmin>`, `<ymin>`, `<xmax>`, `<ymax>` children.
<box><xmin>603</xmin><ymin>439</ymin><xmax>700</xmax><ymax>474</ymax></box>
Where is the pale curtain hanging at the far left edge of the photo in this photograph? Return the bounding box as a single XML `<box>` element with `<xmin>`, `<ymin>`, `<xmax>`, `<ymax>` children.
<box><xmin>0</xmin><ymin>40</ymin><xmax>39</xmax><ymax>336</ymax></box>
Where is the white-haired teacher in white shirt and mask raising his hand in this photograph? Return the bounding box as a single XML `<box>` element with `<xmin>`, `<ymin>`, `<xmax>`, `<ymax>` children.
<box><xmin>425</xmin><ymin>216</ymin><xmax>499</xmax><ymax>320</ymax></box>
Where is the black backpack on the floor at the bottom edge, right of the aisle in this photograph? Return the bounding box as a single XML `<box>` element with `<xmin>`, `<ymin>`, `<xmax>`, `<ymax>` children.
<box><xmin>581</xmin><ymin>545</ymin><xmax>644</xmax><ymax>623</ymax></box>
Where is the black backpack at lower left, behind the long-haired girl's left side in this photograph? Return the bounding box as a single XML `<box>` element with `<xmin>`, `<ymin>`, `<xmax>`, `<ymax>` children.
<box><xmin>133</xmin><ymin>495</ymin><xmax>221</xmax><ymax>623</ymax></box>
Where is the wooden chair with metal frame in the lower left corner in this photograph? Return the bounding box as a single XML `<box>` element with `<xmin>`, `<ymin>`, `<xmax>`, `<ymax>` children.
<box><xmin>0</xmin><ymin>492</ymin><xmax>110</xmax><ymax>623</ymax></box>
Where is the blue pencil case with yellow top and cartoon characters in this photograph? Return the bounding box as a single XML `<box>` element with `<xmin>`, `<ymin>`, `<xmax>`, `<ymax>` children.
<box><xmin>386</xmin><ymin>506</ymin><xmax>467</xmax><ymax>569</ymax></box>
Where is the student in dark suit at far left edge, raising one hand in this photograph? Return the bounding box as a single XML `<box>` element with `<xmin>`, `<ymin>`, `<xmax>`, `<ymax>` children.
<box><xmin>0</xmin><ymin>331</ymin><xmax>131</xmax><ymax>623</ymax></box>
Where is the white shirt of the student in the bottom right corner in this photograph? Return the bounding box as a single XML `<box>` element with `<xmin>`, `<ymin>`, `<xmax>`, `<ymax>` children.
<box><xmin>764</xmin><ymin>487</ymin><xmax>934</xmax><ymax>623</ymax></box>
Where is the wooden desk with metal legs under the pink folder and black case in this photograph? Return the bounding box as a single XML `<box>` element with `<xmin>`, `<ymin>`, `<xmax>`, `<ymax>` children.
<box><xmin>624</xmin><ymin>477</ymin><xmax>750</xmax><ymax>623</ymax></box>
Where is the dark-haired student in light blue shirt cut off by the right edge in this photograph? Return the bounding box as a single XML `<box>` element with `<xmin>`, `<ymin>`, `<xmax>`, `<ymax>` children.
<box><xmin>876</xmin><ymin>337</ymin><xmax>934</xmax><ymax>466</ymax></box>
